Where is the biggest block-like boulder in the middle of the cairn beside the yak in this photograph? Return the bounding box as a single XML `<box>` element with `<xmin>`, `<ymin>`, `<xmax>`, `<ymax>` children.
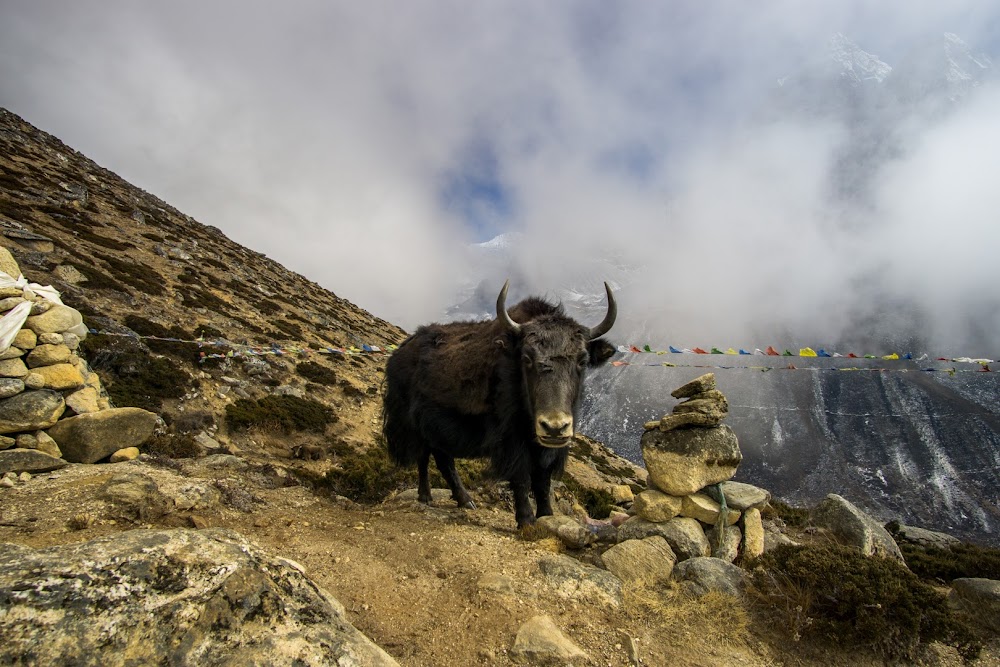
<box><xmin>642</xmin><ymin>424</ymin><xmax>743</xmax><ymax>496</ymax></box>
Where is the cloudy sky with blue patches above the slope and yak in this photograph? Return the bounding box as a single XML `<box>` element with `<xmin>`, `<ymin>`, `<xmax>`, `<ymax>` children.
<box><xmin>0</xmin><ymin>0</ymin><xmax>1000</xmax><ymax>357</ymax></box>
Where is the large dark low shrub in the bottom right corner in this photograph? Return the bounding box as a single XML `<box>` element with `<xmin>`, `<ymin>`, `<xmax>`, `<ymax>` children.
<box><xmin>749</xmin><ymin>545</ymin><xmax>980</xmax><ymax>660</ymax></box>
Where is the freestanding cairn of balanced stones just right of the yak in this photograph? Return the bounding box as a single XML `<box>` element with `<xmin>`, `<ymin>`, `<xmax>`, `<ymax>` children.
<box><xmin>618</xmin><ymin>373</ymin><xmax>771</xmax><ymax>562</ymax></box>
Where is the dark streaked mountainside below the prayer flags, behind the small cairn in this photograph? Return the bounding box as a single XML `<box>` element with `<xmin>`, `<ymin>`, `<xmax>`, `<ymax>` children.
<box><xmin>581</xmin><ymin>366</ymin><xmax>1000</xmax><ymax>544</ymax></box>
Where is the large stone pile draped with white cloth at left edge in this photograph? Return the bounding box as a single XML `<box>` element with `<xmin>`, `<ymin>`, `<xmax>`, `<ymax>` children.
<box><xmin>0</xmin><ymin>247</ymin><xmax>158</xmax><ymax>487</ymax></box>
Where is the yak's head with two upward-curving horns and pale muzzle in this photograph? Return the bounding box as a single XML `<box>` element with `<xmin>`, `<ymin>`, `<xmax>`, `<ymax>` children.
<box><xmin>497</xmin><ymin>283</ymin><xmax>618</xmax><ymax>448</ymax></box>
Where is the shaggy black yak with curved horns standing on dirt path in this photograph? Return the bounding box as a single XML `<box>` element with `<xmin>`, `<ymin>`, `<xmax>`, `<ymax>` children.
<box><xmin>382</xmin><ymin>280</ymin><xmax>618</xmax><ymax>529</ymax></box>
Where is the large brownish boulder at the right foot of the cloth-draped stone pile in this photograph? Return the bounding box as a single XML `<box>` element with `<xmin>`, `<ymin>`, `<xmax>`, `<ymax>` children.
<box><xmin>47</xmin><ymin>408</ymin><xmax>157</xmax><ymax>463</ymax></box>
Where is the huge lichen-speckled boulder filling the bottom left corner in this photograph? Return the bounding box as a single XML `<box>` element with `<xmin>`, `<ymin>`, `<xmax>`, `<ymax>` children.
<box><xmin>0</xmin><ymin>529</ymin><xmax>397</xmax><ymax>667</ymax></box>
